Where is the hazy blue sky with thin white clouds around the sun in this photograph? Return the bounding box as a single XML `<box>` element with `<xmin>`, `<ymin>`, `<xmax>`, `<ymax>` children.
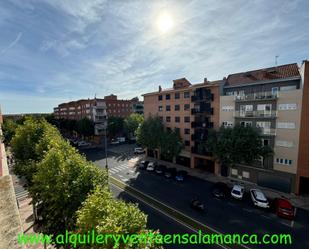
<box><xmin>0</xmin><ymin>0</ymin><xmax>309</xmax><ymax>114</ymax></box>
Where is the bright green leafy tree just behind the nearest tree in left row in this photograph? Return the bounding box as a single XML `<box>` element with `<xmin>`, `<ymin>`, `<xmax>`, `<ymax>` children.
<box><xmin>30</xmin><ymin>140</ymin><xmax>107</xmax><ymax>238</ymax></box>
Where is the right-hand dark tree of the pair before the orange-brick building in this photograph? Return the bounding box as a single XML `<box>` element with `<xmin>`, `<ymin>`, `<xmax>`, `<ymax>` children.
<box><xmin>160</xmin><ymin>129</ymin><xmax>183</xmax><ymax>160</ymax></box>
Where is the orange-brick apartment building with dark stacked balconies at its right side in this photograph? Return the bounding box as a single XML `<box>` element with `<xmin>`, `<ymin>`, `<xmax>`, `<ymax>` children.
<box><xmin>143</xmin><ymin>78</ymin><xmax>222</xmax><ymax>173</ymax></box>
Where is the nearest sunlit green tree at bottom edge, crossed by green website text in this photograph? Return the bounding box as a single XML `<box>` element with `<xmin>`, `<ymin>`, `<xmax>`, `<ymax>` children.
<box><xmin>77</xmin><ymin>188</ymin><xmax>162</xmax><ymax>249</ymax></box>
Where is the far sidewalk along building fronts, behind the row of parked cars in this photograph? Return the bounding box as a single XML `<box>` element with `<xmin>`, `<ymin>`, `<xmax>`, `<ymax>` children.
<box><xmin>147</xmin><ymin>157</ymin><xmax>309</xmax><ymax>211</ymax></box>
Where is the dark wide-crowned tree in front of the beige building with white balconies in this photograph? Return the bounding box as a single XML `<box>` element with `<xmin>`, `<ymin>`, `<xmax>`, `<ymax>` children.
<box><xmin>205</xmin><ymin>125</ymin><xmax>272</xmax><ymax>165</ymax></box>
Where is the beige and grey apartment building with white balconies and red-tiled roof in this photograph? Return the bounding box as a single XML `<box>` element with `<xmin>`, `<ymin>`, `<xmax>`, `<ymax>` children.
<box><xmin>220</xmin><ymin>63</ymin><xmax>302</xmax><ymax>192</ymax></box>
